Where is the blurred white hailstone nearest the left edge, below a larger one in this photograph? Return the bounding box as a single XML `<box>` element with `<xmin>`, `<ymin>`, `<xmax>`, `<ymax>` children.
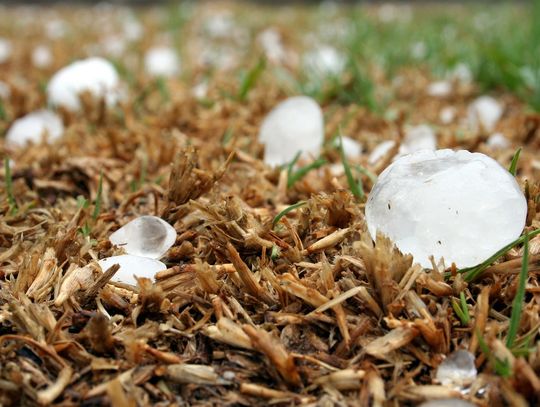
<box><xmin>6</xmin><ymin>110</ymin><xmax>64</xmax><ymax>147</ymax></box>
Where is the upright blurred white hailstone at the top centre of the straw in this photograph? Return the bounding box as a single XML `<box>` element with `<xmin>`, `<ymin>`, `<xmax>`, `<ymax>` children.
<box><xmin>259</xmin><ymin>96</ymin><xmax>324</xmax><ymax>165</ymax></box>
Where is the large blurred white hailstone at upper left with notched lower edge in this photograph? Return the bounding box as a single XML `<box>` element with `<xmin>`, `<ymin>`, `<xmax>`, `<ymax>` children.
<box><xmin>47</xmin><ymin>57</ymin><xmax>120</xmax><ymax>111</ymax></box>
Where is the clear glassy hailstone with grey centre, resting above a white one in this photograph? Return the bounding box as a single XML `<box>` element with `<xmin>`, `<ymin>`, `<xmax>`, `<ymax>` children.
<box><xmin>109</xmin><ymin>216</ymin><xmax>176</xmax><ymax>259</ymax></box>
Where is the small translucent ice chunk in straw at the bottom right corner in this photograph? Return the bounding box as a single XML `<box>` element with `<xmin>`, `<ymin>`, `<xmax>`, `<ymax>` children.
<box><xmin>435</xmin><ymin>349</ymin><xmax>477</xmax><ymax>388</ymax></box>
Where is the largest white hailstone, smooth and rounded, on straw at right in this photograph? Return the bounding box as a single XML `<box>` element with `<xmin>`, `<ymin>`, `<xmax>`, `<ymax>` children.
<box><xmin>366</xmin><ymin>150</ymin><xmax>527</xmax><ymax>268</ymax></box>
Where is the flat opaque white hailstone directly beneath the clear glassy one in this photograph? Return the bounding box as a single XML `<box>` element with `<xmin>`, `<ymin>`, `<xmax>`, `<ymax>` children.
<box><xmin>98</xmin><ymin>254</ymin><xmax>167</xmax><ymax>285</ymax></box>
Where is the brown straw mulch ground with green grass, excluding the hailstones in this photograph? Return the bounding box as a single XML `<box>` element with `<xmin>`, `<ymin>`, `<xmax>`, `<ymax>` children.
<box><xmin>0</xmin><ymin>3</ymin><xmax>540</xmax><ymax>406</ymax></box>
